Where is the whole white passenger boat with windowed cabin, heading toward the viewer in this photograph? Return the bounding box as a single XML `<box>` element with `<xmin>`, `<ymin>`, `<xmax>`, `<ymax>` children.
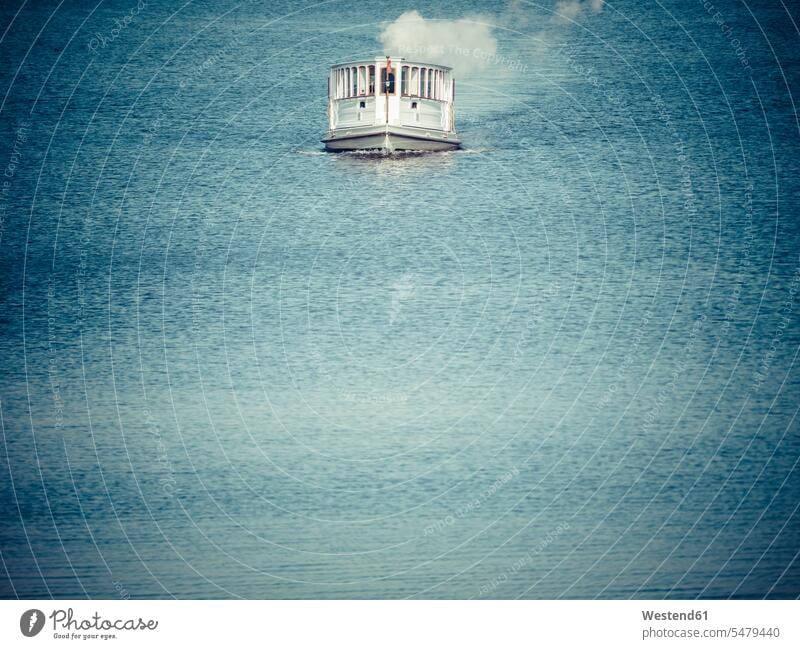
<box><xmin>322</xmin><ymin>56</ymin><xmax>461</xmax><ymax>151</ymax></box>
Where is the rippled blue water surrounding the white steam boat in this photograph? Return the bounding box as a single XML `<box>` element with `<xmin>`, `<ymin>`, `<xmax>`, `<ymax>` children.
<box><xmin>0</xmin><ymin>0</ymin><xmax>800</xmax><ymax>598</ymax></box>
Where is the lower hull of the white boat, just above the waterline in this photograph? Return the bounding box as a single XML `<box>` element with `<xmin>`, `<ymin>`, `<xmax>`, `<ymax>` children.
<box><xmin>322</xmin><ymin>126</ymin><xmax>461</xmax><ymax>151</ymax></box>
